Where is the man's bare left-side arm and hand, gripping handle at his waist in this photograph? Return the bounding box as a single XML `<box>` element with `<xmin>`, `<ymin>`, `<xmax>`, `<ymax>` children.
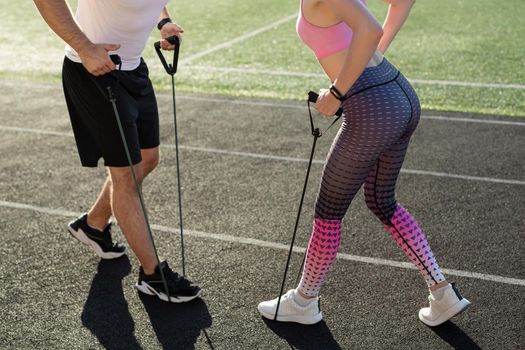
<box><xmin>34</xmin><ymin>0</ymin><xmax>120</xmax><ymax>75</ymax></box>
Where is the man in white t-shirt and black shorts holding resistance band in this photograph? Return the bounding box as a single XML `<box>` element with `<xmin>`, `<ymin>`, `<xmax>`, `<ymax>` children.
<box><xmin>34</xmin><ymin>0</ymin><xmax>201</xmax><ymax>302</ymax></box>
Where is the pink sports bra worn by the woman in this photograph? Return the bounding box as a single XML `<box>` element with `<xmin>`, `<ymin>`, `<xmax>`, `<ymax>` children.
<box><xmin>296</xmin><ymin>0</ymin><xmax>364</xmax><ymax>59</ymax></box>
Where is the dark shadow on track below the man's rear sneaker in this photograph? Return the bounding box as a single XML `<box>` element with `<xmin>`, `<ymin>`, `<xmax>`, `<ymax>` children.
<box><xmin>81</xmin><ymin>256</ymin><xmax>142</xmax><ymax>349</ymax></box>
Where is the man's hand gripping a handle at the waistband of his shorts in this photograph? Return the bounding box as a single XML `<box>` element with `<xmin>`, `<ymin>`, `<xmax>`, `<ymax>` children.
<box><xmin>77</xmin><ymin>43</ymin><xmax>120</xmax><ymax>76</ymax></box>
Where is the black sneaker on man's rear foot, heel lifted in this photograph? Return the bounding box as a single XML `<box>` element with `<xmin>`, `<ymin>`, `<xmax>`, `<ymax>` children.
<box><xmin>67</xmin><ymin>213</ymin><xmax>126</xmax><ymax>259</ymax></box>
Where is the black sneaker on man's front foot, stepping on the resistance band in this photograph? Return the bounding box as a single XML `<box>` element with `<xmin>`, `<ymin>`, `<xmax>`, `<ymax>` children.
<box><xmin>135</xmin><ymin>261</ymin><xmax>202</xmax><ymax>303</ymax></box>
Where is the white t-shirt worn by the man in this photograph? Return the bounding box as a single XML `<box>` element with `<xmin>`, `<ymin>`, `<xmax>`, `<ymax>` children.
<box><xmin>66</xmin><ymin>0</ymin><xmax>168</xmax><ymax>70</ymax></box>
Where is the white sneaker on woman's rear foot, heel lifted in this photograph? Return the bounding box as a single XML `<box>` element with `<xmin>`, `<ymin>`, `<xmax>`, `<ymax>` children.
<box><xmin>419</xmin><ymin>283</ymin><xmax>470</xmax><ymax>327</ymax></box>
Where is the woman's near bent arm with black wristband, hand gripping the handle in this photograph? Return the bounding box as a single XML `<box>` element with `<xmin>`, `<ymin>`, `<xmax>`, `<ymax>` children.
<box><xmin>316</xmin><ymin>0</ymin><xmax>383</xmax><ymax>116</ymax></box>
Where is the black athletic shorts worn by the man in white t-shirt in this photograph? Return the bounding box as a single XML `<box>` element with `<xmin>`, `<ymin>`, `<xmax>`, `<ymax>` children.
<box><xmin>62</xmin><ymin>57</ymin><xmax>159</xmax><ymax>167</ymax></box>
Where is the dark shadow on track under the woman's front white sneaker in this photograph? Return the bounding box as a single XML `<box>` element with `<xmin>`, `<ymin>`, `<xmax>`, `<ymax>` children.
<box><xmin>262</xmin><ymin>317</ymin><xmax>341</xmax><ymax>350</ymax></box>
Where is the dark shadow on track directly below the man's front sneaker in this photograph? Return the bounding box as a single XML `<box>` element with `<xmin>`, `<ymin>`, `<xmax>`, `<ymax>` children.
<box><xmin>139</xmin><ymin>293</ymin><xmax>215</xmax><ymax>349</ymax></box>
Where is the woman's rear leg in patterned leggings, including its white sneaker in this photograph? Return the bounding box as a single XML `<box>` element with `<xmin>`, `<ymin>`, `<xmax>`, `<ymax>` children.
<box><xmin>365</xmin><ymin>77</ymin><xmax>470</xmax><ymax>327</ymax></box>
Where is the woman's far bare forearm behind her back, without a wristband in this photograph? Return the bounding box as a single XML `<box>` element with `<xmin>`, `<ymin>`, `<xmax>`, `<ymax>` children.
<box><xmin>378</xmin><ymin>0</ymin><xmax>416</xmax><ymax>53</ymax></box>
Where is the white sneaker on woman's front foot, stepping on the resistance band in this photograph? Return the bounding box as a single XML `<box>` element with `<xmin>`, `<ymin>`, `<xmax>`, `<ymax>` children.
<box><xmin>257</xmin><ymin>289</ymin><xmax>323</xmax><ymax>324</ymax></box>
